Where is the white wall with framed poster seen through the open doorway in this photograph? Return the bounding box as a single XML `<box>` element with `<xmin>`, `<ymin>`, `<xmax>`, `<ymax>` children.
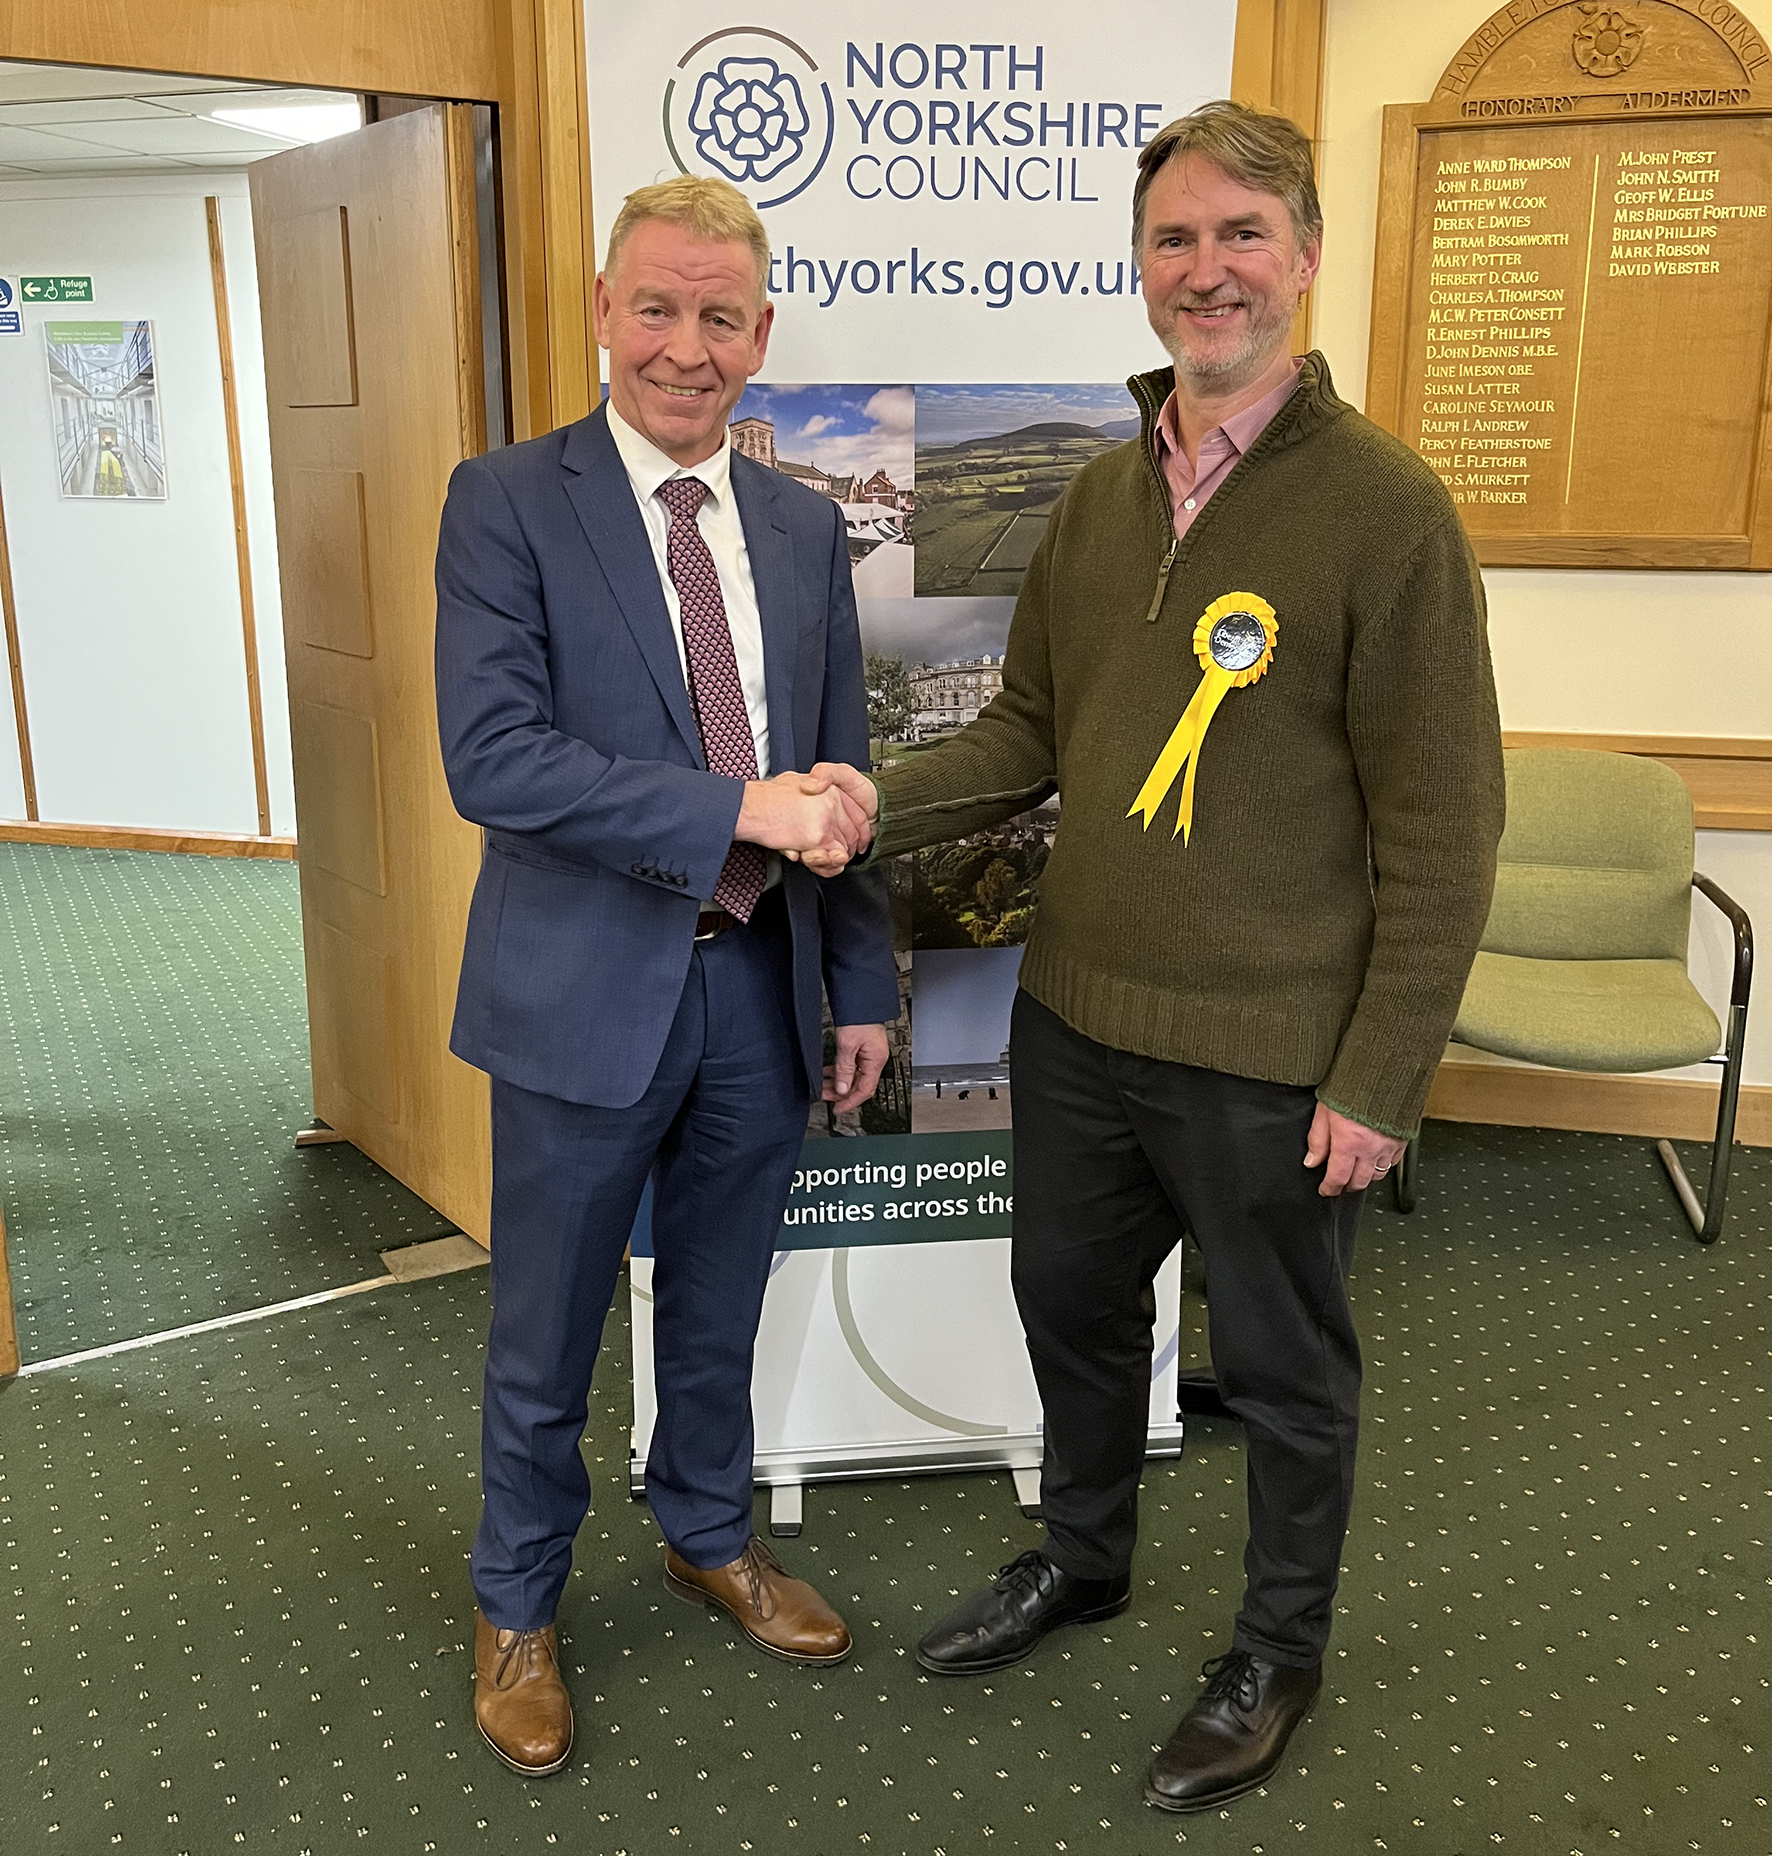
<box><xmin>0</xmin><ymin>171</ymin><xmax>295</xmax><ymax>831</ymax></box>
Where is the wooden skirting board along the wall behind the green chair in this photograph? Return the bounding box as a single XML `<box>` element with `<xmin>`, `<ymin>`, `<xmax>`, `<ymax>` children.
<box><xmin>1427</xmin><ymin>1058</ymin><xmax>1772</xmax><ymax>1147</ymax></box>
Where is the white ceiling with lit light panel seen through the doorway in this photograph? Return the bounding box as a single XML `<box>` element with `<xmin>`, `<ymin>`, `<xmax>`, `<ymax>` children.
<box><xmin>0</xmin><ymin>59</ymin><xmax>362</xmax><ymax>180</ymax></box>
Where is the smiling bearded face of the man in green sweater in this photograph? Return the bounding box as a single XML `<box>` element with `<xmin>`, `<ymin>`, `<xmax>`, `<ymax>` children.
<box><xmin>1139</xmin><ymin>154</ymin><xmax>1323</xmax><ymax>399</ymax></box>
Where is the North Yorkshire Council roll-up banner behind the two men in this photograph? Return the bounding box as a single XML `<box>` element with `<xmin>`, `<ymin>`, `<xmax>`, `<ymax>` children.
<box><xmin>584</xmin><ymin>0</ymin><xmax>1236</xmax><ymax>1487</ymax></box>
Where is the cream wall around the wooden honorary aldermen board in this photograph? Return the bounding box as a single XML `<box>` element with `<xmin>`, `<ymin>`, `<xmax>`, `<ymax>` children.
<box><xmin>1314</xmin><ymin>0</ymin><xmax>1772</xmax><ymax>1084</ymax></box>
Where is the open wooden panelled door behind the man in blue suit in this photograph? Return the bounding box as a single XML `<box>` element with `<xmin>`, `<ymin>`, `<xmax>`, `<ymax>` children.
<box><xmin>250</xmin><ymin>104</ymin><xmax>495</xmax><ymax>1242</ymax></box>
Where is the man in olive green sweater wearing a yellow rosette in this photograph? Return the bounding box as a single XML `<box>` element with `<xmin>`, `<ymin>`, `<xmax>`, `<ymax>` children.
<box><xmin>824</xmin><ymin>102</ymin><xmax>1503</xmax><ymax>1811</ymax></box>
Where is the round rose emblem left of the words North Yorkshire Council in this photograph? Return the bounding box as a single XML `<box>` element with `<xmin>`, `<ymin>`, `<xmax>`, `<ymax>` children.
<box><xmin>664</xmin><ymin>26</ymin><xmax>837</xmax><ymax>208</ymax></box>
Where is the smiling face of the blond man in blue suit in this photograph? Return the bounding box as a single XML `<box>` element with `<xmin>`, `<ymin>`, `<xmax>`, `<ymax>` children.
<box><xmin>592</xmin><ymin>219</ymin><xmax>776</xmax><ymax>466</ymax></box>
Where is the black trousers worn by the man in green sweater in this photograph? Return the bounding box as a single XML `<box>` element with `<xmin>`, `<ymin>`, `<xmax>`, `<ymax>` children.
<box><xmin>1009</xmin><ymin>993</ymin><xmax>1362</xmax><ymax>1667</ymax></box>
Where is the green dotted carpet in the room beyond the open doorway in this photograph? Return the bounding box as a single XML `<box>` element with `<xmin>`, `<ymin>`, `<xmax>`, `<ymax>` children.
<box><xmin>0</xmin><ymin>844</ymin><xmax>451</xmax><ymax>1360</ymax></box>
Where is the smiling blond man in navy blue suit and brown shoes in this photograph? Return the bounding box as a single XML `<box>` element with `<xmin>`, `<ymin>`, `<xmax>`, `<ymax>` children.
<box><xmin>436</xmin><ymin>178</ymin><xmax>898</xmax><ymax>1772</ymax></box>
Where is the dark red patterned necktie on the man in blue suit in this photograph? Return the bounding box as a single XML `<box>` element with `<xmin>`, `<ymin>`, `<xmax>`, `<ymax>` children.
<box><xmin>659</xmin><ymin>477</ymin><xmax>768</xmax><ymax>922</ymax></box>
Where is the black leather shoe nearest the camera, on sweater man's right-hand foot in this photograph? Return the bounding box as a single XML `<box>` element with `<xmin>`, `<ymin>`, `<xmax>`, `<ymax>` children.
<box><xmin>1145</xmin><ymin>1650</ymin><xmax>1323</xmax><ymax>1811</ymax></box>
